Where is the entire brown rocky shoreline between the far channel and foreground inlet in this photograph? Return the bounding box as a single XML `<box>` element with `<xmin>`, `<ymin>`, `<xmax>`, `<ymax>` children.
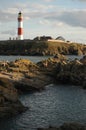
<box><xmin>0</xmin><ymin>54</ymin><xmax>86</xmax><ymax>117</ymax></box>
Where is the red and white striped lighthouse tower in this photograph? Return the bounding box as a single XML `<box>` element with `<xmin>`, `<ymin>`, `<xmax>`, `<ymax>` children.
<box><xmin>18</xmin><ymin>12</ymin><xmax>23</xmax><ymax>40</ymax></box>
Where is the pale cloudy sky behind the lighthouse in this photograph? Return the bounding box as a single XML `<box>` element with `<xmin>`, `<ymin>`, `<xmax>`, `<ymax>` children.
<box><xmin>0</xmin><ymin>0</ymin><xmax>86</xmax><ymax>43</ymax></box>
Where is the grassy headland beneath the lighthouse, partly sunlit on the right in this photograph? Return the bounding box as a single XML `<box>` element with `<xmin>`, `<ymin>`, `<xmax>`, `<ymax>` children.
<box><xmin>0</xmin><ymin>40</ymin><xmax>86</xmax><ymax>55</ymax></box>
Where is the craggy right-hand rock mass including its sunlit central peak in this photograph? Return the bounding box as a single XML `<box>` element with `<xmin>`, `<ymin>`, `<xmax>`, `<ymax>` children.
<box><xmin>37</xmin><ymin>55</ymin><xmax>86</xmax><ymax>88</ymax></box>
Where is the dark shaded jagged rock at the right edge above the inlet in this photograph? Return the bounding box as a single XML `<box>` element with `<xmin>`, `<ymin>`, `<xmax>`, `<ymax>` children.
<box><xmin>57</xmin><ymin>56</ymin><xmax>86</xmax><ymax>88</ymax></box>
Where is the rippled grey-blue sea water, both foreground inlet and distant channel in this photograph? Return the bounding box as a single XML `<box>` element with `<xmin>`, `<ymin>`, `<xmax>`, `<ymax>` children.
<box><xmin>0</xmin><ymin>56</ymin><xmax>86</xmax><ymax>130</ymax></box>
